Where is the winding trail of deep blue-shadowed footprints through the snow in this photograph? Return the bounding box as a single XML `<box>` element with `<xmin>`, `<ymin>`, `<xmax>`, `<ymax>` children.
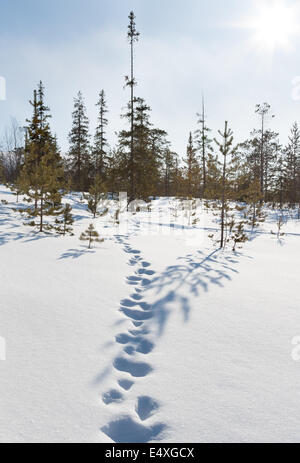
<box><xmin>102</xmin><ymin>231</ymin><xmax>166</xmax><ymax>443</ymax></box>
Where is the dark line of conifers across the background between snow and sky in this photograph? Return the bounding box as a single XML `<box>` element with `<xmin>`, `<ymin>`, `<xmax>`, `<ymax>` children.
<box><xmin>0</xmin><ymin>12</ymin><xmax>300</xmax><ymax>219</ymax></box>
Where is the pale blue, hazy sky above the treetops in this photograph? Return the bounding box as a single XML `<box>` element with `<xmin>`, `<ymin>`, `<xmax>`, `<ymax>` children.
<box><xmin>0</xmin><ymin>0</ymin><xmax>300</xmax><ymax>156</ymax></box>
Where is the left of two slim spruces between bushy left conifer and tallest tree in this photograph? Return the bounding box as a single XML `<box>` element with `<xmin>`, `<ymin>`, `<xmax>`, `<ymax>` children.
<box><xmin>69</xmin><ymin>92</ymin><xmax>90</xmax><ymax>192</ymax></box>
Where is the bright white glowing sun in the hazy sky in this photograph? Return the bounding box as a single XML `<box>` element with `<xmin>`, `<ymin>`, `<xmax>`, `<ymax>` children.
<box><xmin>247</xmin><ymin>0</ymin><xmax>299</xmax><ymax>52</ymax></box>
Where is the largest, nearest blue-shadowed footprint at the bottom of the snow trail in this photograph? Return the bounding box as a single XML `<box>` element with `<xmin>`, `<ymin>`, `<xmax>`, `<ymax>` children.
<box><xmin>101</xmin><ymin>416</ymin><xmax>166</xmax><ymax>444</ymax></box>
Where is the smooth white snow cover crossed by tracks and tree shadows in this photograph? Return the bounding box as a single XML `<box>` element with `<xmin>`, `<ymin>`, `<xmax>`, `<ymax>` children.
<box><xmin>0</xmin><ymin>186</ymin><xmax>300</xmax><ymax>443</ymax></box>
